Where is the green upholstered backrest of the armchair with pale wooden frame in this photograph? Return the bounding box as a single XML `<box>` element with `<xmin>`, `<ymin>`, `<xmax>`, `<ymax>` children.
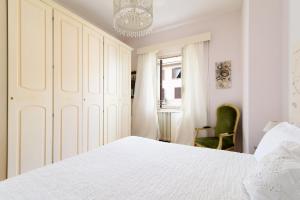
<box><xmin>215</xmin><ymin>104</ymin><xmax>240</xmax><ymax>143</ymax></box>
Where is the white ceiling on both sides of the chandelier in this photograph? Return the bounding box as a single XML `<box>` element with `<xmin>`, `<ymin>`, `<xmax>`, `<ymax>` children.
<box><xmin>55</xmin><ymin>0</ymin><xmax>242</xmax><ymax>40</ymax></box>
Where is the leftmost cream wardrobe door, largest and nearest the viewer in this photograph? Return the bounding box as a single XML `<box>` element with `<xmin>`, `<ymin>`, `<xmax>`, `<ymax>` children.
<box><xmin>8</xmin><ymin>0</ymin><xmax>52</xmax><ymax>177</ymax></box>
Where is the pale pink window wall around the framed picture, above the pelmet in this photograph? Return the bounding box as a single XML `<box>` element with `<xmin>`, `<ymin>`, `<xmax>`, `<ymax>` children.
<box><xmin>126</xmin><ymin>11</ymin><xmax>243</xmax><ymax>151</ymax></box>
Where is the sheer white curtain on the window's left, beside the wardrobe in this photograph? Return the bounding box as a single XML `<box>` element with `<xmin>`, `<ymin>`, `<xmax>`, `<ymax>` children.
<box><xmin>132</xmin><ymin>53</ymin><xmax>159</xmax><ymax>139</ymax></box>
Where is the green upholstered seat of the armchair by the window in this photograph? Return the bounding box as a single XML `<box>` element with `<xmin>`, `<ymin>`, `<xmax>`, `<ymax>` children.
<box><xmin>195</xmin><ymin>137</ymin><xmax>233</xmax><ymax>149</ymax></box>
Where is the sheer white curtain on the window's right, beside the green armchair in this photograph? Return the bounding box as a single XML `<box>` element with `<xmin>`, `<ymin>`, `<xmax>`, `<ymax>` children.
<box><xmin>176</xmin><ymin>43</ymin><xmax>208</xmax><ymax>145</ymax></box>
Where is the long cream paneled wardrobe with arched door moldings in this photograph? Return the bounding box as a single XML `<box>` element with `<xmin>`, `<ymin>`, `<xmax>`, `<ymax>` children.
<box><xmin>7</xmin><ymin>0</ymin><xmax>132</xmax><ymax>177</ymax></box>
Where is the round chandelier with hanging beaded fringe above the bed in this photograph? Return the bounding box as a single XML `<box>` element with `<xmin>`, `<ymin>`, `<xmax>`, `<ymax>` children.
<box><xmin>114</xmin><ymin>0</ymin><xmax>153</xmax><ymax>37</ymax></box>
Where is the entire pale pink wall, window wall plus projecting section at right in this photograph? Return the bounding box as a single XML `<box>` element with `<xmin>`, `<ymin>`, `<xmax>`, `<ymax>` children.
<box><xmin>126</xmin><ymin>0</ymin><xmax>290</xmax><ymax>153</ymax></box>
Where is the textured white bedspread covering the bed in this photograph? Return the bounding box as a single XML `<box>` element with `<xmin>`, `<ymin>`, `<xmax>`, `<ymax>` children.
<box><xmin>0</xmin><ymin>137</ymin><xmax>256</xmax><ymax>200</ymax></box>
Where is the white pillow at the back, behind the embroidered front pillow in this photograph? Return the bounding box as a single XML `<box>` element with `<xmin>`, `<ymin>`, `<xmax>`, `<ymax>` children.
<box><xmin>254</xmin><ymin>122</ymin><xmax>300</xmax><ymax>161</ymax></box>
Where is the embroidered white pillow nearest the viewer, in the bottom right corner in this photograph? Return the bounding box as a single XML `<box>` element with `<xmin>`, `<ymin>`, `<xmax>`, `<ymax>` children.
<box><xmin>243</xmin><ymin>142</ymin><xmax>300</xmax><ymax>200</ymax></box>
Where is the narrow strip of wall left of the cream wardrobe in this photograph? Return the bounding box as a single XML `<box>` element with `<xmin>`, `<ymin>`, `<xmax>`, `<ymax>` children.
<box><xmin>0</xmin><ymin>0</ymin><xmax>7</xmax><ymax>180</ymax></box>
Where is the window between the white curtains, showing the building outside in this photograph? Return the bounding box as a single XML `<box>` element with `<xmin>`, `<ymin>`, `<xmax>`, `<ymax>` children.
<box><xmin>157</xmin><ymin>56</ymin><xmax>182</xmax><ymax>108</ymax></box>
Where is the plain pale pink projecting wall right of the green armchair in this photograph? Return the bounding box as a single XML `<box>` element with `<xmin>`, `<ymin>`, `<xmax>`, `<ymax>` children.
<box><xmin>243</xmin><ymin>0</ymin><xmax>288</xmax><ymax>153</ymax></box>
